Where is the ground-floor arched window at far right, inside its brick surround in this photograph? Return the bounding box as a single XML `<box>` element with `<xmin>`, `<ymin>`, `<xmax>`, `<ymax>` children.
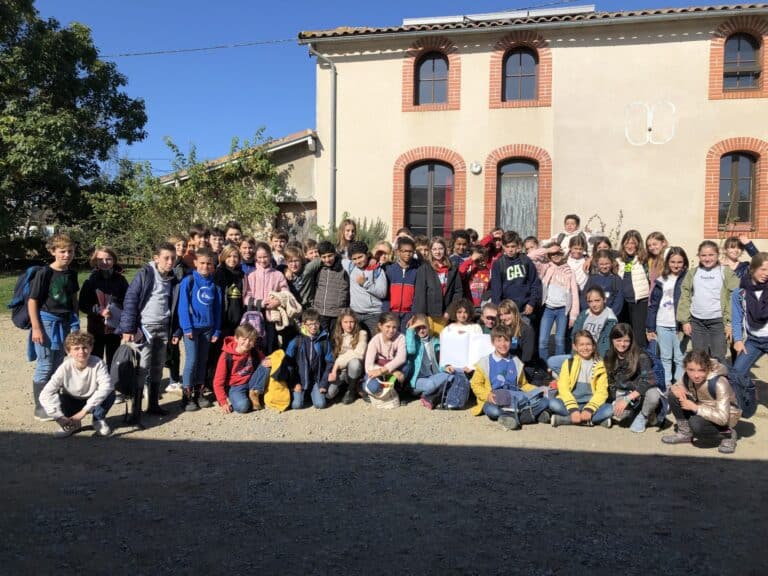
<box><xmin>717</xmin><ymin>152</ymin><xmax>756</xmax><ymax>228</ymax></box>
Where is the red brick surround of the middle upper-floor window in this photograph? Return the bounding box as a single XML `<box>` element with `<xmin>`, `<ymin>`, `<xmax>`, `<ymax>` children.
<box><xmin>489</xmin><ymin>31</ymin><xmax>552</xmax><ymax>108</ymax></box>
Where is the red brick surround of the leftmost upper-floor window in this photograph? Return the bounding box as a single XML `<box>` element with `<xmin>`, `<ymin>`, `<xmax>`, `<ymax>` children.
<box><xmin>402</xmin><ymin>37</ymin><xmax>461</xmax><ymax>112</ymax></box>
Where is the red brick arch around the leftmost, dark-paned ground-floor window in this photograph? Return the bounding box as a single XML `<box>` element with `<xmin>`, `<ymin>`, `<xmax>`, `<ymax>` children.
<box><xmin>392</xmin><ymin>146</ymin><xmax>467</xmax><ymax>236</ymax></box>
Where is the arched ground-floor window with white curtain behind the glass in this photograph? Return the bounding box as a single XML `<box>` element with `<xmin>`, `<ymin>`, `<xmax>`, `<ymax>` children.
<box><xmin>496</xmin><ymin>158</ymin><xmax>539</xmax><ymax>238</ymax></box>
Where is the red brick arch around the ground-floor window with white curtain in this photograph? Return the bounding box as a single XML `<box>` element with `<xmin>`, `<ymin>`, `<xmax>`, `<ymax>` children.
<box><xmin>483</xmin><ymin>144</ymin><xmax>552</xmax><ymax>238</ymax></box>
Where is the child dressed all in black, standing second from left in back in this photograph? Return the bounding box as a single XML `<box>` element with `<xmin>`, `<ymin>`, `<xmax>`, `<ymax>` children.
<box><xmin>78</xmin><ymin>246</ymin><xmax>128</xmax><ymax>370</ymax></box>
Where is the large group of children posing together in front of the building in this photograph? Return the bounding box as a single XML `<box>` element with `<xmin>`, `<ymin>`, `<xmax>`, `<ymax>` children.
<box><xmin>28</xmin><ymin>215</ymin><xmax>768</xmax><ymax>453</ymax></box>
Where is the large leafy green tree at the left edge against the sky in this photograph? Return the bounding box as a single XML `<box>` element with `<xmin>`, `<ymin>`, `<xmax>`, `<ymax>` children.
<box><xmin>0</xmin><ymin>0</ymin><xmax>147</xmax><ymax>235</ymax></box>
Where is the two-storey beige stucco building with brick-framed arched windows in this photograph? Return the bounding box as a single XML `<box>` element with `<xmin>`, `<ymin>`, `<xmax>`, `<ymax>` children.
<box><xmin>300</xmin><ymin>4</ymin><xmax>768</xmax><ymax>247</ymax></box>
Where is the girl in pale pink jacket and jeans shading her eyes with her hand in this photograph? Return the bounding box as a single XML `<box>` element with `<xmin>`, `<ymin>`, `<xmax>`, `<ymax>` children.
<box><xmin>532</xmin><ymin>244</ymin><xmax>579</xmax><ymax>362</ymax></box>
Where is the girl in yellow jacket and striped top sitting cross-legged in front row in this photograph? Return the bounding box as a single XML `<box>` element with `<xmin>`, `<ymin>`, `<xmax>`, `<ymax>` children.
<box><xmin>549</xmin><ymin>330</ymin><xmax>613</xmax><ymax>428</ymax></box>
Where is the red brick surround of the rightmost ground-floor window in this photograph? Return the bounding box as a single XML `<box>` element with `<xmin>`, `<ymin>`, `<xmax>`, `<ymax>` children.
<box><xmin>704</xmin><ymin>137</ymin><xmax>768</xmax><ymax>238</ymax></box>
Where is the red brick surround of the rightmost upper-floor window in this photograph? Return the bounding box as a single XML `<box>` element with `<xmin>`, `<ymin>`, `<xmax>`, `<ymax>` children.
<box><xmin>709</xmin><ymin>16</ymin><xmax>768</xmax><ymax>100</ymax></box>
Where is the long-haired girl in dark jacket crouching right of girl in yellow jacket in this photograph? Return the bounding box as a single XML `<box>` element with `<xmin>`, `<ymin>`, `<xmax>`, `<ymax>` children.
<box><xmin>605</xmin><ymin>324</ymin><xmax>664</xmax><ymax>433</ymax></box>
